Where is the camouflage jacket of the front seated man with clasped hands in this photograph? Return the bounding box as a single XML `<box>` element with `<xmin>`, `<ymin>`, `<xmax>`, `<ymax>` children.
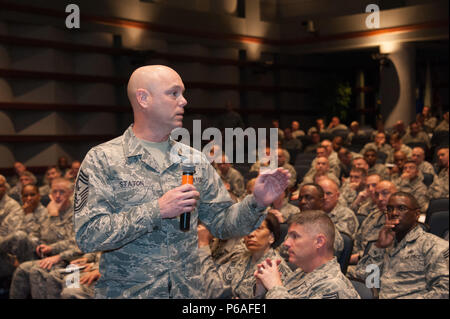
<box><xmin>266</xmin><ymin>257</ymin><xmax>360</xmax><ymax>299</ymax></box>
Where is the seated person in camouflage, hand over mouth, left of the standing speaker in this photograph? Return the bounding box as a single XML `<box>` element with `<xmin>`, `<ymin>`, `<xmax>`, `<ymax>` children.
<box><xmin>10</xmin><ymin>178</ymin><xmax>82</xmax><ymax>299</ymax></box>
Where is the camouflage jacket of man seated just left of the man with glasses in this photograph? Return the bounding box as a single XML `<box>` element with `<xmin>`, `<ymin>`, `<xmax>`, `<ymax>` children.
<box><xmin>353</xmin><ymin>207</ymin><xmax>385</xmax><ymax>257</ymax></box>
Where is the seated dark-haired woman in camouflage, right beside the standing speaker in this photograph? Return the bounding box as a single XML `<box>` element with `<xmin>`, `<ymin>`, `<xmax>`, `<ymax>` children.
<box><xmin>198</xmin><ymin>214</ymin><xmax>290</xmax><ymax>299</ymax></box>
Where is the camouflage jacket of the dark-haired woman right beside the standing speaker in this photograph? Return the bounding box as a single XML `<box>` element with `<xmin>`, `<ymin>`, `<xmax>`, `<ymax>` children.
<box><xmin>198</xmin><ymin>247</ymin><xmax>291</xmax><ymax>299</ymax></box>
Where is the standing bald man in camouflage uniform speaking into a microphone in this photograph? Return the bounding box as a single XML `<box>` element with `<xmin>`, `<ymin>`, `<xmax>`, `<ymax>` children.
<box><xmin>75</xmin><ymin>65</ymin><xmax>290</xmax><ymax>298</ymax></box>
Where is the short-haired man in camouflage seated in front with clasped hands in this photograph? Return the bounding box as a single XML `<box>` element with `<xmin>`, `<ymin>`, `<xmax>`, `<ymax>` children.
<box><xmin>254</xmin><ymin>211</ymin><xmax>360</xmax><ymax>299</ymax></box>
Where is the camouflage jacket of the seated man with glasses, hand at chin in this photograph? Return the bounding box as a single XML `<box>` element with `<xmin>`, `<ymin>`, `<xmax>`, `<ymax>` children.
<box><xmin>357</xmin><ymin>226</ymin><xmax>449</xmax><ymax>299</ymax></box>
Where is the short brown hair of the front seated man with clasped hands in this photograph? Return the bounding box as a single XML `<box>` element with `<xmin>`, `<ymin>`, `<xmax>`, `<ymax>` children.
<box><xmin>289</xmin><ymin>210</ymin><xmax>336</xmax><ymax>253</ymax></box>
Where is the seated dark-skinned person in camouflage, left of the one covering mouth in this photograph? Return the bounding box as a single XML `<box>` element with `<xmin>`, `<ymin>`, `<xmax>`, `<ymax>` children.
<box><xmin>0</xmin><ymin>184</ymin><xmax>47</xmax><ymax>277</ymax></box>
